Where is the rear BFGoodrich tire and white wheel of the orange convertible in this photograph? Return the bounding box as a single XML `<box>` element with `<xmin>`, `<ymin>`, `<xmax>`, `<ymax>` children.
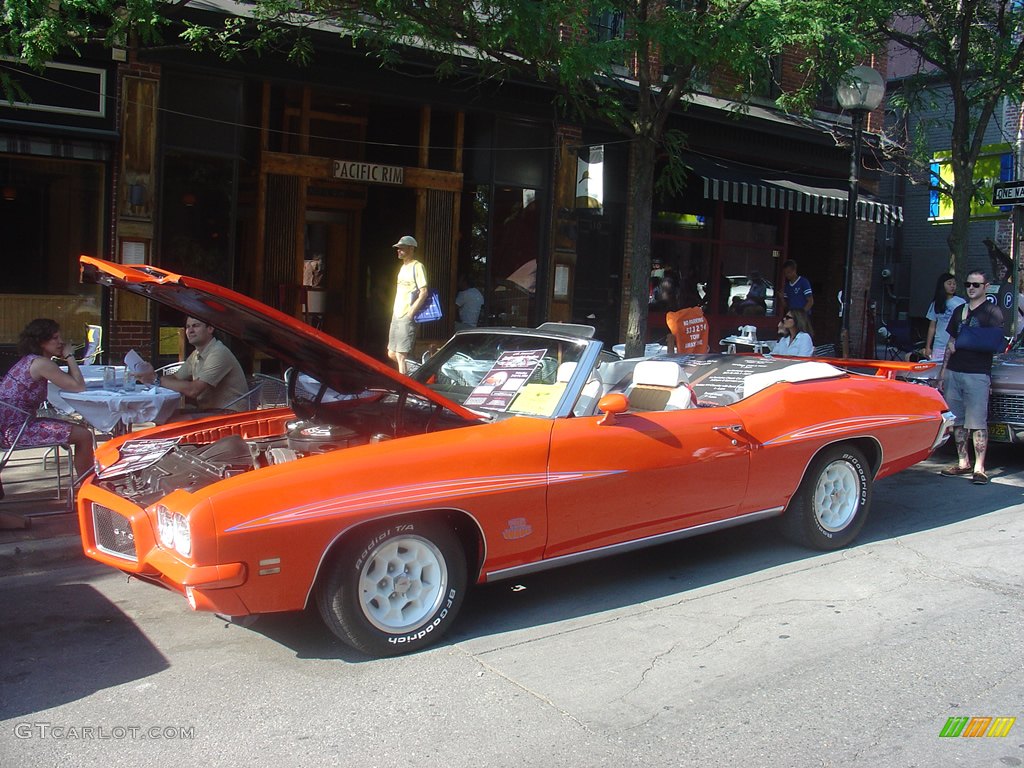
<box><xmin>782</xmin><ymin>445</ymin><xmax>872</xmax><ymax>550</ymax></box>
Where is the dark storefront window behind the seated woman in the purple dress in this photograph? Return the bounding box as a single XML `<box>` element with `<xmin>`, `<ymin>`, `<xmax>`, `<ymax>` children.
<box><xmin>0</xmin><ymin>155</ymin><xmax>106</xmax><ymax>345</ymax></box>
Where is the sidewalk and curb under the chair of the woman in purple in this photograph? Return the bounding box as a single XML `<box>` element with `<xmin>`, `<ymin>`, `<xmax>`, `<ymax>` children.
<box><xmin>0</xmin><ymin>449</ymin><xmax>85</xmax><ymax>577</ymax></box>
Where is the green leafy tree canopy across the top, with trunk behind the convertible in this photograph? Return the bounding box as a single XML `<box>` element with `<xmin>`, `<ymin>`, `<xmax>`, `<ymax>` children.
<box><xmin>0</xmin><ymin>0</ymin><xmax>868</xmax><ymax>353</ymax></box>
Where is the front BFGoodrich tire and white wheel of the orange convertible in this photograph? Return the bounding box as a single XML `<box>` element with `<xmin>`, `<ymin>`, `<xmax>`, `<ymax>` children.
<box><xmin>316</xmin><ymin>520</ymin><xmax>466</xmax><ymax>656</ymax></box>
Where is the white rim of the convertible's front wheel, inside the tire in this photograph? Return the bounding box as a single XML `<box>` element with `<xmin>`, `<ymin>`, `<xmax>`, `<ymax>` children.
<box><xmin>358</xmin><ymin>536</ymin><xmax>447</xmax><ymax>634</ymax></box>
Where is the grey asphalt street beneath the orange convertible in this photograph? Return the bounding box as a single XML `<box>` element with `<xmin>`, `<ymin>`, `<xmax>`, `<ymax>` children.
<box><xmin>0</xmin><ymin>446</ymin><xmax>1024</xmax><ymax>768</ymax></box>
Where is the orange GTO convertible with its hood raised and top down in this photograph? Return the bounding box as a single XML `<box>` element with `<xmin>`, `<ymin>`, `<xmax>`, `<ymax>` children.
<box><xmin>77</xmin><ymin>257</ymin><xmax>951</xmax><ymax>655</ymax></box>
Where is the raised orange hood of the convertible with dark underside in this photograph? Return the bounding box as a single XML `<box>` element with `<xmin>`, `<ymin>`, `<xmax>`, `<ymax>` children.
<box><xmin>80</xmin><ymin>256</ymin><xmax>481</xmax><ymax>421</ymax></box>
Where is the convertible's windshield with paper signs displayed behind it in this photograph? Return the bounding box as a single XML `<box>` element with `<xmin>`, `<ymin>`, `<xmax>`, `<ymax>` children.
<box><xmin>405</xmin><ymin>333</ymin><xmax>587</xmax><ymax>418</ymax></box>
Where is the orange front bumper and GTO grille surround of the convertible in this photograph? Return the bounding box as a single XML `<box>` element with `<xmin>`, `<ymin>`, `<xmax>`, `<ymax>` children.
<box><xmin>78</xmin><ymin>482</ymin><xmax>249</xmax><ymax>615</ymax></box>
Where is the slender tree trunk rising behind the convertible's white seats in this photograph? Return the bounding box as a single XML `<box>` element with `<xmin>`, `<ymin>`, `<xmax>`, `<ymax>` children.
<box><xmin>626</xmin><ymin>136</ymin><xmax>655</xmax><ymax>357</ymax></box>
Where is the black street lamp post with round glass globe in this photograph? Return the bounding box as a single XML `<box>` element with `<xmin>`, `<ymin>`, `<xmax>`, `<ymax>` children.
<box><xmin>836</xmin><ymin>67</ymin><xmax>886</xmax><ymax>357</ymax></box>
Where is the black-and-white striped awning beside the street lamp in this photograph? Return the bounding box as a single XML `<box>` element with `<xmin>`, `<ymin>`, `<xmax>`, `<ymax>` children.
<box><xmin>686</xmin><ymin>157</ymin><xmax>903</xmax><ymax>225</ymax></box>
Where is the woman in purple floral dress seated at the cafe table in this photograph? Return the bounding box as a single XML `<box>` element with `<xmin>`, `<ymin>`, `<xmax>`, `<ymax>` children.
<box><xmin>0</xmin><ymin>318</ymin><xmax>92</xmax><ymax>499</ymax></box>
